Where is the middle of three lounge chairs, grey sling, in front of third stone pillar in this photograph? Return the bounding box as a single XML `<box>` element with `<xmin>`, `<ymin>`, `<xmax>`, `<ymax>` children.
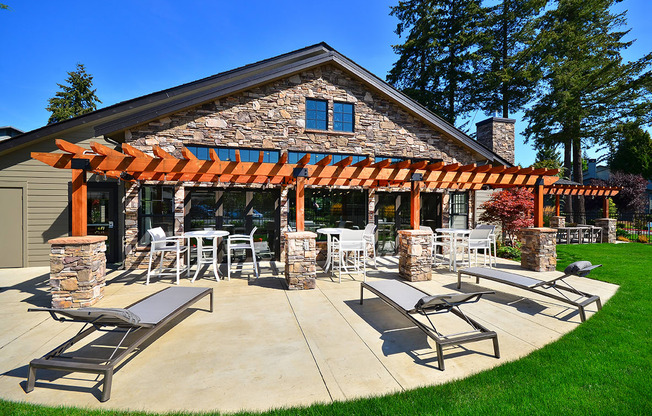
<box><xmin>360</xmin><ymin>280</ymin><xmax>500</xmax><ymax>371</ymax></box>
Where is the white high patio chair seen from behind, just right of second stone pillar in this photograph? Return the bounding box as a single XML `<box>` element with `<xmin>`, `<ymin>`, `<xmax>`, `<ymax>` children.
<box><xmin>332</xmin><ymin>229</ymin><xmax>367</xmax><ymax>283</ymax></box>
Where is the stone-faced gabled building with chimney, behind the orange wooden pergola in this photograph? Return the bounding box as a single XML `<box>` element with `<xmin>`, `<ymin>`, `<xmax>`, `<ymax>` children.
<box><xmin>0</xmin><ymin>43</ymin><xmax>514</xmax><ymax>268</ymax></box>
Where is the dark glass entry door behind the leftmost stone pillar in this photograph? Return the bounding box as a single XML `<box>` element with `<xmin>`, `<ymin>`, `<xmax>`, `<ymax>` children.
<box><xmin>87</xmin><ymin>183</ymin><xmax>119</xmax><ymax>263</ymax></box>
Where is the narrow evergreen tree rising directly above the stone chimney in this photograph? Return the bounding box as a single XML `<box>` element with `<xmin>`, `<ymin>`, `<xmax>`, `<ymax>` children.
<box><xmin>477</xmin><ymin>0</ymin><xmax>548</xmax><ymax>118</ymax></box>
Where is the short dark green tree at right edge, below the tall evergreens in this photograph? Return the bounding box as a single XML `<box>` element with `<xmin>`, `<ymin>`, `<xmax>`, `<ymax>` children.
<box><xmin>610</xmin><ymin>122</ymin><xmax>652</xmax><ymax>180</ymax></box>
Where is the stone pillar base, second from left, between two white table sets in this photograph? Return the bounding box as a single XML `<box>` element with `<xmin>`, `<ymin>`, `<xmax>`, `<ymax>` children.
<box><xmin>285</xmin><ymin>231</ymin><xmax>317</xmax><ymax>289</ymax></box>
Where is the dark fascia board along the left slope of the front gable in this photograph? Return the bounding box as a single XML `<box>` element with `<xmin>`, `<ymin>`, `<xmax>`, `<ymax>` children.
<box><xmin>95</xmin><ymin>54</ymin><xmax>332</xmax><ymax>135</ymax></box>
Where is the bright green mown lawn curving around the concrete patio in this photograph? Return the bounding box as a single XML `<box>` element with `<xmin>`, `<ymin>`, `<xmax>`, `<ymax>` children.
<box><xmin>0</xmin><ymin>243</ymin><xmax>652</xmax><ymax>415</ymax></box>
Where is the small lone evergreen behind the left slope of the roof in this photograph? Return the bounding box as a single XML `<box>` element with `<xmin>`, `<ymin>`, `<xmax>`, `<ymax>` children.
<box><xmin>45</xmin><ymin>64</ymin><xmax>102</xmax><ymax>124</ymax></box>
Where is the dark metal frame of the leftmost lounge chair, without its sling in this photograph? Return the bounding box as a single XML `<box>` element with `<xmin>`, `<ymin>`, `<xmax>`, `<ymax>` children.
<box><xmin>25</xmin><ymin>287</ymin><xmax>213</xmax><ymax>402</ymax></box>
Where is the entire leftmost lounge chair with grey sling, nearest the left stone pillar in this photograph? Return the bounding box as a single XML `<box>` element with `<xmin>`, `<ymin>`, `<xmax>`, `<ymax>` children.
<box><xmin>25</xmin><ymin>287</ymin><xmax>213</xmax><ymax>402</ymax></box>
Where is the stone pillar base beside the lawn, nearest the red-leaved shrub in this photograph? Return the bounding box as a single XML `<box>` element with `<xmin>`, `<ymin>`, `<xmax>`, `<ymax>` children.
<box><xmin>519</xmin><ymin>227</ymin><xmax>557</xmax><ymax>272</ymax></box>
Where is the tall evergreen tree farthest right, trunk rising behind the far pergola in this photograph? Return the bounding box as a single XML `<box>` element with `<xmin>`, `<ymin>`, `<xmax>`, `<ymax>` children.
<box><xmin>525</xmin><ymin>0</ymin><xmax>652</xmax><ymax>221</ymax></box>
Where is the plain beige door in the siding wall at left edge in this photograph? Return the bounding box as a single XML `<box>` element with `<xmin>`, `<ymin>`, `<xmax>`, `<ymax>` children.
<box><xmin>0</xmin><ymin>187</ymin><xmax>24</xmax><ymax>268</ymax></box>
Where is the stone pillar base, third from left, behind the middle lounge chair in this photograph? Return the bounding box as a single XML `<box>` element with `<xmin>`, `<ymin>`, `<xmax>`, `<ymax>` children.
<box><xmin>398</xmin><ymin>230</ymin><xmax>432</xmax><ymax>282</ymax></box>
